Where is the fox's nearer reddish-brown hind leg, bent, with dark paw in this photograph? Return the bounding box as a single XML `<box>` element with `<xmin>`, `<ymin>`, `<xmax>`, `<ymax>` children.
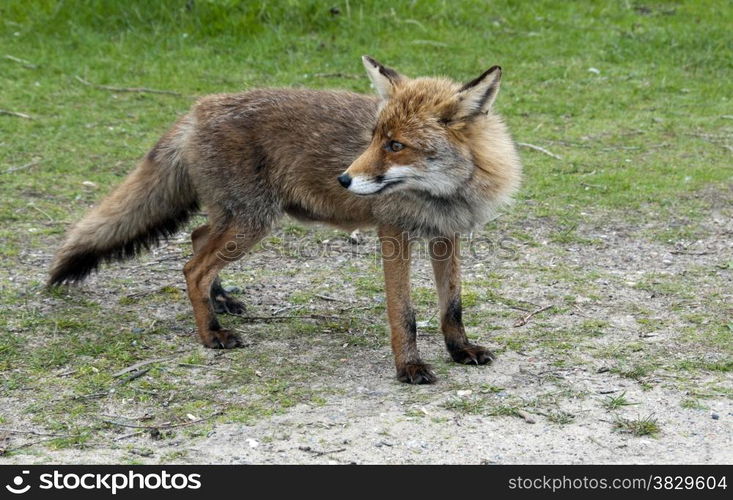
<box><xmin>183</xmin><ymin>225</ymin><xmax>266</xmax><ymax>349</ymax></box>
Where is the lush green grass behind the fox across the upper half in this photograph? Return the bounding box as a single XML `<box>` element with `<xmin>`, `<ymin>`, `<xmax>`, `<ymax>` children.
<box><xmin>0</xmin><ymin>0</ymin><xmax>733</xmax><ymax>225</ymax></box>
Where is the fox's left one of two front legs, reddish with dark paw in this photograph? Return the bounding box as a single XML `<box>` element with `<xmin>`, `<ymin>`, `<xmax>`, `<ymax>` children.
<box><xmin>379</xmin><ymin>227</ymin><xmax>435</xmax><ymax>384</ymax></box>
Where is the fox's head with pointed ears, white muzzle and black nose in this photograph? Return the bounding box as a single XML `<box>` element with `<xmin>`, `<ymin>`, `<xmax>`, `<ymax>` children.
<box><xmin>338</xmin><ymin>56</ymin><xmax>501</xmax><ymax>196</ymax></box>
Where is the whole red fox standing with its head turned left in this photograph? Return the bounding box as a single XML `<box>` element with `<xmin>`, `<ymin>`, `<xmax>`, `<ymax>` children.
<box><xmin>49</xmin><ymin>56</ymin><xmax>521</xmax><ymax>384</ymax></box>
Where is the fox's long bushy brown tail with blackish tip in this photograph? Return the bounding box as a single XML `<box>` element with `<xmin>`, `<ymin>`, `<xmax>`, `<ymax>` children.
<box><xmin>48</xmin><ymin>123</ymin><xmax>198</xmax><ymax>285</ymax></box>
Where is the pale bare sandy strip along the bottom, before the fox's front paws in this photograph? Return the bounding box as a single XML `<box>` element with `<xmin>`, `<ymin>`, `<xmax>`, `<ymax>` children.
<box><xmin>3</xmin><ymin>355</ymin><xmax>733</xmax><ymax>464</ymax></box>
